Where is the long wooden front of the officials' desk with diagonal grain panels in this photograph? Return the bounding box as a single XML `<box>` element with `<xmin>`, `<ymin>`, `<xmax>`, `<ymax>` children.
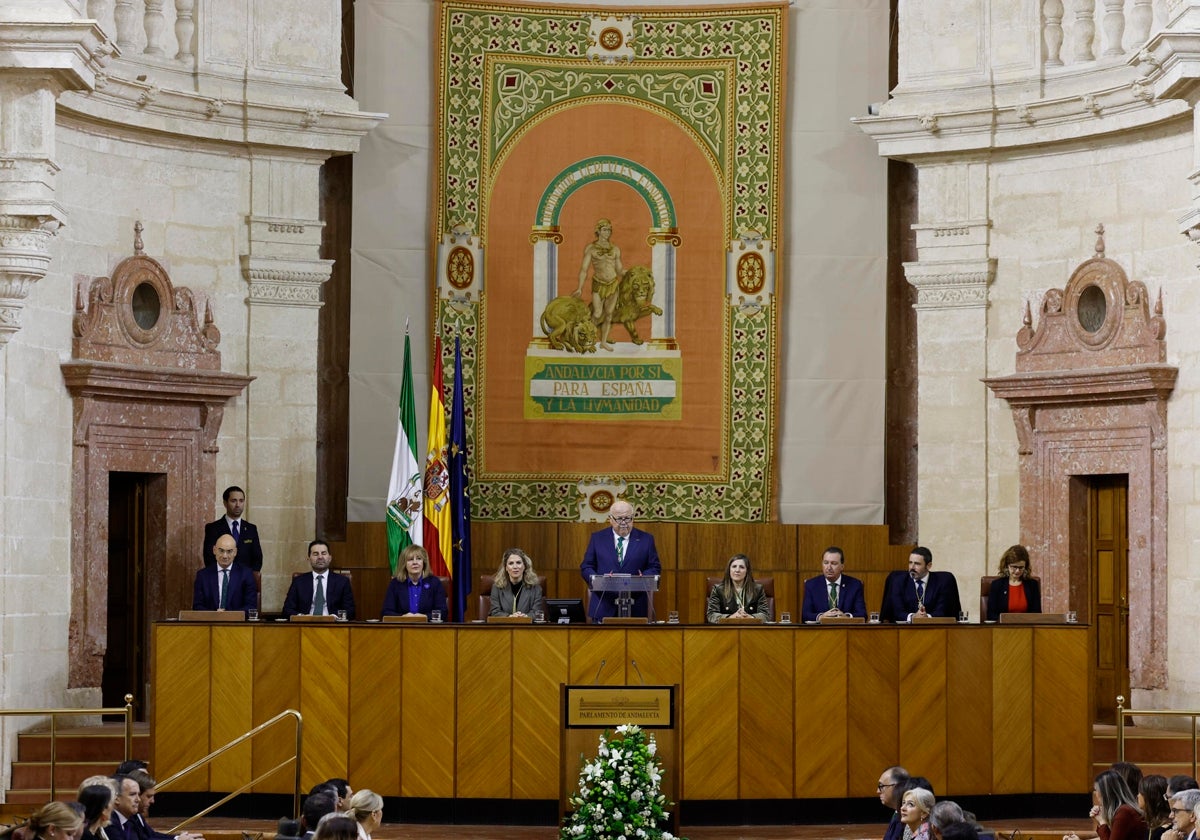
<box><xmin>154</xmin><ymin>623</ymin><xmax>1091</xmax><ymax>800</ymax></box>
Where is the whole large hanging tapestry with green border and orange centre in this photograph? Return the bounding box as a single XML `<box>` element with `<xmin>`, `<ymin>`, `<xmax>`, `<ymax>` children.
<box><xmin>432</xmin><ymin>0</ymin><xmax>787</xmax><ymax>522</ymax></box>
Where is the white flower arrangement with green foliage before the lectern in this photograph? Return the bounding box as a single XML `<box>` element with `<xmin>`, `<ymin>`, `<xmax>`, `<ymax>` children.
<box><xmin>559</xmin><ymin>724</ymin><xmax>683</xmax><ymax>840</ymax></box>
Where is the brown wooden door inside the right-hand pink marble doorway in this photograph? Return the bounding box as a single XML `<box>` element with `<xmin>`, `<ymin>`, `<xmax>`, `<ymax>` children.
<box><xmin>1087</xmin><ymin>475</ymin><xmax>1129</xmax><ymax>724</ymax></box>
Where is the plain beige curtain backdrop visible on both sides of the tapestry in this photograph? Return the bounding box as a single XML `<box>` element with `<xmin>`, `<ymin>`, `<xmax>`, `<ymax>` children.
<box><xmin>347</xmin><ymin>0</ymin><xmax>888</xmax><ymax>523</ymax></box>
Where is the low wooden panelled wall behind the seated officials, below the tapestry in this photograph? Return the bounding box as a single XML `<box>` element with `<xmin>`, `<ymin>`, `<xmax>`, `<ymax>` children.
<box><xmin>324</xmin><ymin>522</ymin><xmax>912</xmax><ymax>624</ymax></box>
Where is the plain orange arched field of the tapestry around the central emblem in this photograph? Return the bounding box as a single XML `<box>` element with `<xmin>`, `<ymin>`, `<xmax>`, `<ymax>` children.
<box><xmin>475</xmin><ymin>100</ymin><xmax>728</xmax><ymax>480</ymax></box>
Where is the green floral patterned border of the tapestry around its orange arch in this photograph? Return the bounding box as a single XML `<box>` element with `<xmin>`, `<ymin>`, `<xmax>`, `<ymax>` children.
<box><xmin>432</xmin><ymin>0</ymin><xmax>787</xmax><ymax>522</ymax></box>
